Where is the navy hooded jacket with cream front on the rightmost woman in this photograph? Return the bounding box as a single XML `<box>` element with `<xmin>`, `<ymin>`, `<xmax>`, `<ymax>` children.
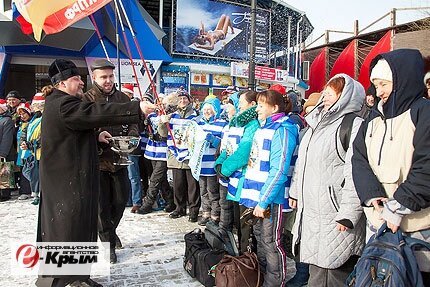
<box><xmin>352</xmin><ymin>49</ymin><xmax>430</xmax><ymax>220</ymax></box>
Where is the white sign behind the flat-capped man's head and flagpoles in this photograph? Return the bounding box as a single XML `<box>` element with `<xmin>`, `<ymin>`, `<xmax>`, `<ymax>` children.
<box><xmin>85</xmin><ymin>57</ymin><xmax>162</xmax><ymax>97</ymax></box>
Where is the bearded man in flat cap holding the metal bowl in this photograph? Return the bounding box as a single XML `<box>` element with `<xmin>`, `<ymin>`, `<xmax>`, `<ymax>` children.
<box><xmin>82</xmin><ymin>59</ymin><xmax>139</xmax><ymax>263</ymax></box>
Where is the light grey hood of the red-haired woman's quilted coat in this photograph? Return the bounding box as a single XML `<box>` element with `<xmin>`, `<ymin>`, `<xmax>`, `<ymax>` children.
<box><xmin>305</xmin><ymin>74</ymin><xmax>366</xmax><ymax>128</ymax></box>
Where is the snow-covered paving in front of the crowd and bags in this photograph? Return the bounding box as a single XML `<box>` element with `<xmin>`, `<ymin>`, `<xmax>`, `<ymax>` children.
<box><xmin>0</xmin><ymin>191</ymin><xmax>202</xmax><ymax>287</ymax></box>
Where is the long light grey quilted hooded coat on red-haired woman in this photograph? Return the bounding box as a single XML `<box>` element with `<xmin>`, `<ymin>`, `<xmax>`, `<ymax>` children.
<box><xmin>290</xmin><ymin>74</ymin><xmax>365</xmax><ymax>269</ymax></box>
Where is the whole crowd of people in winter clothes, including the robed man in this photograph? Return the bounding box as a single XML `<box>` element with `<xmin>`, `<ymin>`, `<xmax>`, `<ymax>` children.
<box><xmin>0</xmin><ymin>49</ymin><xmax>430</xmax><ymax>286</ymax></box>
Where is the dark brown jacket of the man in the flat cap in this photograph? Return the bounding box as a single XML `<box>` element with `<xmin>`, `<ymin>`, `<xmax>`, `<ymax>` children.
<box><xmin>82</xmin><ymin>84</ymin><xmax>139</xmax><ymax>172</ymax></box>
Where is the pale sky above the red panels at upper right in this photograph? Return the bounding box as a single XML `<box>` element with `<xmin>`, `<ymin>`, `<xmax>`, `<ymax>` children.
<box><xmin>284</xmin><ymin>0</ymin><xmax>430</xmax><ymax>44</ymax></box>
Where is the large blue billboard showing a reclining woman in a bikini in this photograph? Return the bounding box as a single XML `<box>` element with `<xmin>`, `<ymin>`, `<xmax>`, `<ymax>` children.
<box><xmin>172</xmin><ymin>0</ymin><xmax>270</xmax><ymax>63</ymax></box>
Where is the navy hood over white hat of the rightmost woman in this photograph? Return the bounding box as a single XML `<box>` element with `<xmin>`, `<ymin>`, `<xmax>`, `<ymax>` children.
<box><xmin>370</xmin><ymin>49</ymin><xmax>424</xmax><ymax>118</ymax></box>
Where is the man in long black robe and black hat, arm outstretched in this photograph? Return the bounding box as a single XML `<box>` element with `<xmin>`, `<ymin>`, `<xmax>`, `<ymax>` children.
<box><xmin>36</xmin><ymin>59</ymin><xmax>153</xmax><ymax>286</ymax></box>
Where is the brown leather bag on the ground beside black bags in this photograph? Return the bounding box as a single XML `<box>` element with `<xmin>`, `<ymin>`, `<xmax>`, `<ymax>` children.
<box><xmin>215</xmin><ymin>252</ymin><xmax>264</xmax><ymax>287</ymax></box>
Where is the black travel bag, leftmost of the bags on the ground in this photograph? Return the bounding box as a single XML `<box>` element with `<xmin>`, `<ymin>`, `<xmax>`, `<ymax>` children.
<box><xmin>184</xmin><ymin>228</ymin><xmax>225</xmax><ymax>287</ymax></box>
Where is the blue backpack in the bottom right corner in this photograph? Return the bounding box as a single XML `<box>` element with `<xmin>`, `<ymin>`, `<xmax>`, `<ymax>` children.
<box><xmin>346</xmin><ymin>223</ymin><xmax>430</xmax><ymax>287</ymax></box>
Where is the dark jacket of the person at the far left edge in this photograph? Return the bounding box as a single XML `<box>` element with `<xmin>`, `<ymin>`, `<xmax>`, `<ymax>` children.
<box><xmin>0</xmin><ymin>111</ymin><xmax>16</xmax><ymax>161</ymax></box>
